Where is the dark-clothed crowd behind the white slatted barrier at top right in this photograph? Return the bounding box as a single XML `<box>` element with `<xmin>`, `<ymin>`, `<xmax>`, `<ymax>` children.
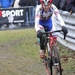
<box><xmin>53</xmin><ymin>0</ymin><xmax>75</xmax><ymax>13</ymax></box>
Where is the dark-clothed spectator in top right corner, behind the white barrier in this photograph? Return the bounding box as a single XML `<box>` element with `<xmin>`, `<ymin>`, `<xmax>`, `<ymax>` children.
<box><xmin>65</xmin><ymin>0</ymin><xmax>75</xmax><ymax>13</ymax></box>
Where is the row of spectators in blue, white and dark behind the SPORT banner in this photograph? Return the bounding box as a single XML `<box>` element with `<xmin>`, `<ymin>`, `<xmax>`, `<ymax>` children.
<box><xmin>0</xmin><ymin>0</ymin><xmax>40</xmax><ymax>8</ymax></box>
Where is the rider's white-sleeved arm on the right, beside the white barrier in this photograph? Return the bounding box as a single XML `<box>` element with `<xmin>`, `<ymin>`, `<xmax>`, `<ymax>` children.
<box><xmin>52</xmin><ymin>4</ymin><xmax>65</xmax><ymax>26</ymax></box>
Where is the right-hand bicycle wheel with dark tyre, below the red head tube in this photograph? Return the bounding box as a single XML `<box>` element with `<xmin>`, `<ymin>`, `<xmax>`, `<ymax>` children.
<box><xmin>52</xmin><ymin>45</ymin><xmax>62</xmax><ymax>75</ymax></box>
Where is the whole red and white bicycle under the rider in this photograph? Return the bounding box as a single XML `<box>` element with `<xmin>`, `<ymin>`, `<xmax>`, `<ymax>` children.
<box><xmin>42</xmin><ymin>30</ymin><xmax>66</xmax><ymax>75</ymax></box>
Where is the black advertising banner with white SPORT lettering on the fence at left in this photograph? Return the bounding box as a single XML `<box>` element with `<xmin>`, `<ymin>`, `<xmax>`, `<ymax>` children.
<box><xmin>0</xmin><ymin>8</ymin><xmax>25</xmax><ymax>24</ymax></box>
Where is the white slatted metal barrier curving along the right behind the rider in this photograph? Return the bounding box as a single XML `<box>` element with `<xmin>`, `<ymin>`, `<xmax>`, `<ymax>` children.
<box><xmin>57</xmin><ymin>10</ymin><xmax>75</xmax><ymax>50</ymax></box>
